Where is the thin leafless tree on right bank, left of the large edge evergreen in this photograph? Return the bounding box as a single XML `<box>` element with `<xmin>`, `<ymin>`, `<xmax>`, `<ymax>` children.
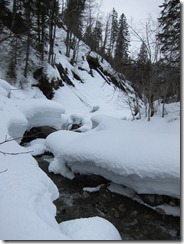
<box><xmin>126</xmin><ymin>16</ymin><xmax>161</xmax><ymax>121</ymax></box>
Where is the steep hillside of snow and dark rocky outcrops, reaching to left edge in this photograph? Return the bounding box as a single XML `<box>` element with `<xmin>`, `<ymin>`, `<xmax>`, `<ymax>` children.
<box><xmin>0</xmin><ymin>23</ymin><xmax>143</xmax><ymax>118</ymax></box>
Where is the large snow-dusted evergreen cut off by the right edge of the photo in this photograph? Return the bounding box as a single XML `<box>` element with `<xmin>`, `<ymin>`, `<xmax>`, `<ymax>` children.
<box><xmin>157</xmin><ymin>0</ymin><xmax>181</xmax><ymax>100</ymax></box>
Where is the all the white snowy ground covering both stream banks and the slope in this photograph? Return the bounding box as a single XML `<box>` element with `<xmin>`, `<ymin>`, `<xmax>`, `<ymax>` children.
<box><xmin>0</xmin><ymin>28</ymin><xmax>180</xmax><ymax>240</ymax></box>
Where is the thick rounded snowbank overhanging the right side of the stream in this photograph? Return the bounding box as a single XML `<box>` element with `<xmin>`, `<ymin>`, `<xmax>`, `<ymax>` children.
<box><xmin>46</xmin><ymin>116</ymin><xmax>180</xmax><ymax>198</ymax></box>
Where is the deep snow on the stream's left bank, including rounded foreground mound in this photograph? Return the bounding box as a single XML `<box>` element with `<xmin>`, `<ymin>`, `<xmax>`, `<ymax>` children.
<box><xmin>0</xmin><ymin>79</ymin><xmax>121</xmax><ymax>240</ymax></box>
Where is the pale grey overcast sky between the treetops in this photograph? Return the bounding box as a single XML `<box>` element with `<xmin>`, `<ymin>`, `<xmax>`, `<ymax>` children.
<box><xmin>96</xmin><ymin>0</ymin><xmax>164</xmax><ymax>55</ymax></box>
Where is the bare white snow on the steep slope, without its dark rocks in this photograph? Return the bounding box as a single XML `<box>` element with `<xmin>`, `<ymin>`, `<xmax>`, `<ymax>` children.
<box><xmin>53</xmin><ymin>29</ymin><xmax>132</xmax><ymax>119</ymax></box>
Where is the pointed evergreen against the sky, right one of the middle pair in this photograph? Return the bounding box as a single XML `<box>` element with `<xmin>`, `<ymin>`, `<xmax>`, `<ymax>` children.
<box><xmin>114</xmin><ymin>14</ymin><xmax>130</xmax><ymax>71</ymax></box>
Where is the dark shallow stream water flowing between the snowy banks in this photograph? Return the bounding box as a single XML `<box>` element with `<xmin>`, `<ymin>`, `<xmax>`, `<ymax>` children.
<box><xmin>36</xmin><ymin>154</ymin><xmax>180</xmax><ymax>240</ymax></box>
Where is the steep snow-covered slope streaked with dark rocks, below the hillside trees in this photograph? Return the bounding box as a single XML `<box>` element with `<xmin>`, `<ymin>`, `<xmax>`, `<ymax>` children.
<box><xmin>41</xmin><ymin>28</ymin><xmax>141</xmax><ymax>118</ymax></box>
